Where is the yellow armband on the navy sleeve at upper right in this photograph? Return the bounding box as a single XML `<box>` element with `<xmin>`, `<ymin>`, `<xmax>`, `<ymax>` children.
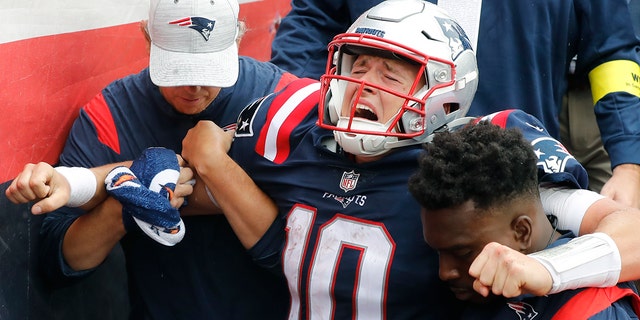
<box><xmin>589</xmin><ymin>60</ymin><xmax>640</xmax><ymax>104</ymax></box>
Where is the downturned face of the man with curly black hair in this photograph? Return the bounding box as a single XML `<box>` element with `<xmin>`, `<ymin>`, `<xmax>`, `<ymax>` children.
<box><xmin>422</xmin><ymin>201</ymin><xmax>511</xmax><ymax>302</ymax></box>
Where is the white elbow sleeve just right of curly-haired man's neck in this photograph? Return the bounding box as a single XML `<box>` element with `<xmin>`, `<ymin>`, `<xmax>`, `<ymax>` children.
<box><xmin>540</xmin><ymin>187</ymin><xmax>604</xmax><ymax>235</ymax></box>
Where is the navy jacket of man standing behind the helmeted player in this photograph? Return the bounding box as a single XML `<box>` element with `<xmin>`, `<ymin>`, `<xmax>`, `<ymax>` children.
<box><xmin>271</xmin><ymin>0</ymin><xmax>640</xmax><ymax>167</ymax></box>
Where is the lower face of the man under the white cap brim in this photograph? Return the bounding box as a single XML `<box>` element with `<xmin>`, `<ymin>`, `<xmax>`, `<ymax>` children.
<box><xmin>160</xmin><ymin>86</ymin><xmax>221</xmax><ymax>115</ymax></box>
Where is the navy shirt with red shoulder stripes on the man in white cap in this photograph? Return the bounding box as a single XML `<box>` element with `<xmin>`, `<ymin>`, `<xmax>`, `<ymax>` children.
<box><xmin>41</xmin><ymin>57</ymin><xmax>295</xmax><ymax>320</ymax></box>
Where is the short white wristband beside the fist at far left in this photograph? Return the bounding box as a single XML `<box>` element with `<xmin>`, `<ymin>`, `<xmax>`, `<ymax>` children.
<box><xmin>55</xmin><ymin>167</ymin><xmax>98</xmax><ymax>207</ymax></box>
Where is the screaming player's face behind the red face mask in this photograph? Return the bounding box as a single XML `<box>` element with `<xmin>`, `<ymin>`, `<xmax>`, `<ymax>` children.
<box><xmin>341</xmin><ymin>55</ymin><xmax>418</xmax><ymax>123</ymax></box>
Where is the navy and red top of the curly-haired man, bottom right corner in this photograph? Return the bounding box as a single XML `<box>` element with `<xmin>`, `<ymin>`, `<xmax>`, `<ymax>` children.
<box><xmin>461</xmin><ymin>232</ymin><xmax>640</xmax><ymax>320</ymax></box>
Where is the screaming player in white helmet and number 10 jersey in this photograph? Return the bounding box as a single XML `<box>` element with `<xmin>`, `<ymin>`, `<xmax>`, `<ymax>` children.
<box><xmin>8</xmin><ymin>0</ymin><xmax>640</xmax><ymax>319</ymax></box>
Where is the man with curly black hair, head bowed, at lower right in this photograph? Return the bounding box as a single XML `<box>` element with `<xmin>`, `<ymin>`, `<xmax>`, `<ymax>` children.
<box><xmin>409</xmin><ymin>122</ymin><xmax>640</xmax><ymax>320</ymax></box>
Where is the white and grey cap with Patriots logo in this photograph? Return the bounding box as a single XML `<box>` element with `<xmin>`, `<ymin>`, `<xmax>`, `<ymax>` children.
<box><xmin>148</xmin><ymin>0</ymin><xmax>240</xmax><ymax>88</ymax></box>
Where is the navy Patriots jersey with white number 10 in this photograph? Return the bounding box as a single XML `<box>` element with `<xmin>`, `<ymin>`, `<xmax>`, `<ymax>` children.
<box><xmin>230</xmin><ymin>79</ymin><xmax>586</xmax><ymax>319</ymax></box>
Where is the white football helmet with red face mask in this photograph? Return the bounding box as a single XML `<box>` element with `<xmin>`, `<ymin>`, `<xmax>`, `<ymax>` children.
<box><xmin>318</xmin><ymin>0</ymin><xmax>478</xmax><ymax>156</ymax></box>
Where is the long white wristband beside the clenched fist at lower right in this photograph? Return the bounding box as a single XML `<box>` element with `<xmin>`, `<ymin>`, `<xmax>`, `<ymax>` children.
<box><xmin>529</xmin><ymin>233</ymin><xmax>622</xmax><ymax>294</ymax></box>
